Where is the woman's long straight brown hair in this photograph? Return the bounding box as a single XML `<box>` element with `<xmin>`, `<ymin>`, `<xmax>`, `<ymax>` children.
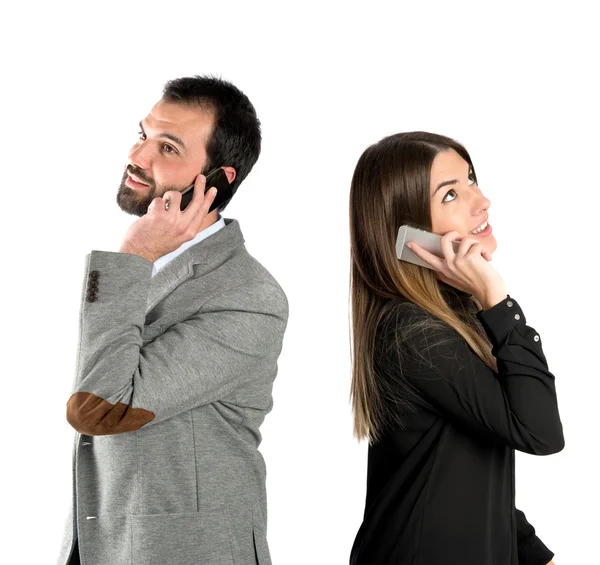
<box><xmin>350</xmin><ymin>132</ymin><xmax>497</xmax><ymax>443</ymax></box>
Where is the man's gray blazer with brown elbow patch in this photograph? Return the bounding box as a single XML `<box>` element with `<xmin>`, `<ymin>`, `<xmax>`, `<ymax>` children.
<box><xmin>58</xmin><ymin>218</ymin><xmax>288</xmax><ymax>565</ymax></box>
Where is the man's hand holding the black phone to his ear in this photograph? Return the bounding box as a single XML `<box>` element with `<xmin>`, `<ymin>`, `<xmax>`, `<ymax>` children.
<box><xmin>119</xmin><ymin>175</ymin><xmax>217</xmax><ymax>263</ymax></box>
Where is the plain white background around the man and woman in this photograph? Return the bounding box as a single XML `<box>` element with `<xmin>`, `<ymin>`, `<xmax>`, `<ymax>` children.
<box><xmin>0</xmin><ymin>1</ymin><xmax>600</xmax><ymax>565</ymax></box>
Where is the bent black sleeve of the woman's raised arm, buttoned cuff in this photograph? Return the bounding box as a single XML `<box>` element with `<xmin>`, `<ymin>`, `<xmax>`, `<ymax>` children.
<box><xmin>387</xmin><ymin>296</ymin><xmax>564</xmax><ymax>455</ymax></box>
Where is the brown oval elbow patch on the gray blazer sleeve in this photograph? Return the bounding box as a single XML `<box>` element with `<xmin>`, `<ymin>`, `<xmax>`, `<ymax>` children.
<box><xmin>67</xmin><ymin>392</ymin><xmax>154</xmax><ymax>436</ymax></box>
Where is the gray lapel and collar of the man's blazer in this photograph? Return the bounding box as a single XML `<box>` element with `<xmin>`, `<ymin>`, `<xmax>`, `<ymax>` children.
<box><xmin>146</xmin><ymin>218</ymin><xmax>244</xmax><ymax>315</ymax></box>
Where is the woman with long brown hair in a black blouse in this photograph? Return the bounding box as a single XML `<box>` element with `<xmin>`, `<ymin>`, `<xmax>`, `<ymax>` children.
<box><xmin>350</xmin><ymin>132</ymin><xmax>564</xmax><ymax>565</ymax></box>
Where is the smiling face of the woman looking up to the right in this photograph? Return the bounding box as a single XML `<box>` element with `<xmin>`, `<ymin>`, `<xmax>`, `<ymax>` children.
<box><xmin>430</xmin><ymin>149</ymin><xmax>497</xmax><ymax>253</ymax></box>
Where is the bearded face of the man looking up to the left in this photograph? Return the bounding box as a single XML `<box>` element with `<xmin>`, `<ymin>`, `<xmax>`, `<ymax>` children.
<box><xmin>117</xmin><ymin>100</ymin><xmax>214</xmax><ymax>217</ymax></box>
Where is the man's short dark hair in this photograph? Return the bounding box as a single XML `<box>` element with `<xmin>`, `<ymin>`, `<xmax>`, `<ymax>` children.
<box><xmin>162</xmin><ymin>75</ymin><xmax>261</xmax><ymax>213</ymax></box>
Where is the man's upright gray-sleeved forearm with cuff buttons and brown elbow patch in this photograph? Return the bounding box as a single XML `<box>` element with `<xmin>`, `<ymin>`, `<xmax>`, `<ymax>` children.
<box><xmin>67</xmin><ymin>251</ymin><xmax>154</xmax><ymax>435</ymax></box>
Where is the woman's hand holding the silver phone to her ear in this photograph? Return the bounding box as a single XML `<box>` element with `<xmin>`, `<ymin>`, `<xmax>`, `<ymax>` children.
<box><xmin>407</xmin><ymin>231</ymin><xmax>507</xmax><ymax>310</ymax></box>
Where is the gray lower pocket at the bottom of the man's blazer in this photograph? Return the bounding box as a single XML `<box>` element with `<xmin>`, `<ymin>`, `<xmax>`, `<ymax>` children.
<box><xmin>131</xmin><ymin>507</ymin><xmax>236</xmax><ymax>565</ymax></box>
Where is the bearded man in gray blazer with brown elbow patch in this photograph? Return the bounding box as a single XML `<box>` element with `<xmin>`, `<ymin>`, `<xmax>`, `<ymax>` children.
<box><xmin>58</xmin><ymin>76</ymin><xmax>288</xmax><ymax>565</ymax></box>
